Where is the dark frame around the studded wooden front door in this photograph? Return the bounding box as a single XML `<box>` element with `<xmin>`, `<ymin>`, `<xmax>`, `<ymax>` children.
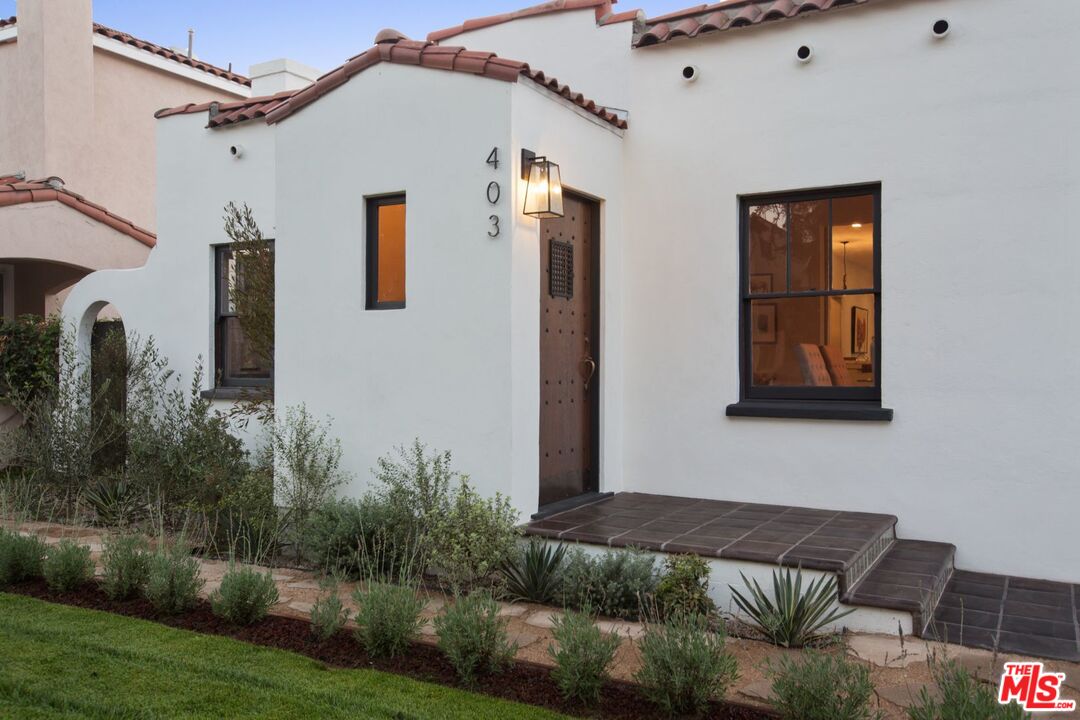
<box><xmin>537</xmin><ymin>186</ymin><xmax>606</xmax><ymax>512</ymax></box>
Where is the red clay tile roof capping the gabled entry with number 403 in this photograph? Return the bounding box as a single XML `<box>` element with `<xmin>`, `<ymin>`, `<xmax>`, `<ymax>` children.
<box><xmin>257</xmin><ymin>35</ymin><xmax>626</xmax><ymax>128</ymax></box>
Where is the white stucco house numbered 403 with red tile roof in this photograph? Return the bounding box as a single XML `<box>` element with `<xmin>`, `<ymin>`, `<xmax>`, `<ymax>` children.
<box><xmin>65</xmin><ymin>0</ymin><xmax>1080</xmax><ymax>656</ymax></box>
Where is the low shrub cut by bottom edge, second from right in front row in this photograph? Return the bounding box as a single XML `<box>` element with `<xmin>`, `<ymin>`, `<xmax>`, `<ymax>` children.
<box><xmin>766</xmin><ymin>651</ymin><xmax>881</xmax><ymax>720</ymax></box>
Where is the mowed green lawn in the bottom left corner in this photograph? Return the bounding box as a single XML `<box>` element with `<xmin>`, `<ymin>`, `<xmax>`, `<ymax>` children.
<box><xmin>0</xmin><ymin>593</ymin><xmax>564</xmax><ymax>720</ymax></box>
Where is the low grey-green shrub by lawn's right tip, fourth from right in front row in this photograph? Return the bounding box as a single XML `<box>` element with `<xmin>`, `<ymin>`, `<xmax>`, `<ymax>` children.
<box><xmin>548</xmin><ymin>610</ymin><xmax>620</xmax><ymax>704</ymax></box>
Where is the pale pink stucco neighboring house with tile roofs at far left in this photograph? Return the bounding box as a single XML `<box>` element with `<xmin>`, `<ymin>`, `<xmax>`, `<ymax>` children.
<box><xmin>0</xmin><ymin>0</ymin><xmax>251</xmax><ymax>317</ymax></box>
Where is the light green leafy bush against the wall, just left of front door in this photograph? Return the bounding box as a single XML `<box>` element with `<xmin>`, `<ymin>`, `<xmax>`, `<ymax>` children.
<box><xmin>429</xmin><ymin>477</ymin><xmax>521</xmax><ymax>593</ymax></box>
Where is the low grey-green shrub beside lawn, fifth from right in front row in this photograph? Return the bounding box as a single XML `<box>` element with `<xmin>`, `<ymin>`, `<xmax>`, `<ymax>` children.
<box><xmin>435</xmin><ymin>592</ymin><xmax>517</xmax><ymax>685</ymax></box>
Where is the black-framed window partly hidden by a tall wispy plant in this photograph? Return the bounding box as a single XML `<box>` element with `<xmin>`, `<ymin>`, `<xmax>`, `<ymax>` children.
<box><xmin>214</xmin><ymin>245</ymin><xmax>273</xmax><ymax>388</ymax></box>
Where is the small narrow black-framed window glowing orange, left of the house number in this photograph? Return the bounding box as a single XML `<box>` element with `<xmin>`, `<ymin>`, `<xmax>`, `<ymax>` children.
<box><xmin>367</xmin><ymin>194</ymin><xmax>405</xmax><ymax>310</ymax></box>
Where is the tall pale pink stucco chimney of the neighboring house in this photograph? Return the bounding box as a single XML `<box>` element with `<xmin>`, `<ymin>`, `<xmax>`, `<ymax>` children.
<box><xmin>12</xmin><ymin>0</ymin><xmax>94</xmax><ymax>189</ymax></box>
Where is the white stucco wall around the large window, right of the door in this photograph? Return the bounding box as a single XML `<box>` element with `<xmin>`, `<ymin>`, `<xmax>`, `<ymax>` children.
<box><xmin>625</xmin><ymin>0</ymin><xmax>1080</xmax><ymax>581</ymax></box>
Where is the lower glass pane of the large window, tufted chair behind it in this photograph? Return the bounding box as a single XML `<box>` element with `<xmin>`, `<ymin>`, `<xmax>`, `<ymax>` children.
<box><xmin>748</xmin><ymin>295</ymin><xmax>876</xmax><ymax>388</ymax></box>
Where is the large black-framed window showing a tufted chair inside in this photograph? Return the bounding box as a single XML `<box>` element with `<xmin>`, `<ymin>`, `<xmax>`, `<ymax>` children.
<box><xmin>732</xmin><ymin>185</ymin><xmax>891</xmax><ymax>417</ymax></box>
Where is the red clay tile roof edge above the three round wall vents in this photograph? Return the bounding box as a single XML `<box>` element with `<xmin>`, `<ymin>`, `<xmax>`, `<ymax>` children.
<box><xmin>634</xmin><ymin>0</ymin><xmax>868</xmax><ymax>47</ymax></box>
